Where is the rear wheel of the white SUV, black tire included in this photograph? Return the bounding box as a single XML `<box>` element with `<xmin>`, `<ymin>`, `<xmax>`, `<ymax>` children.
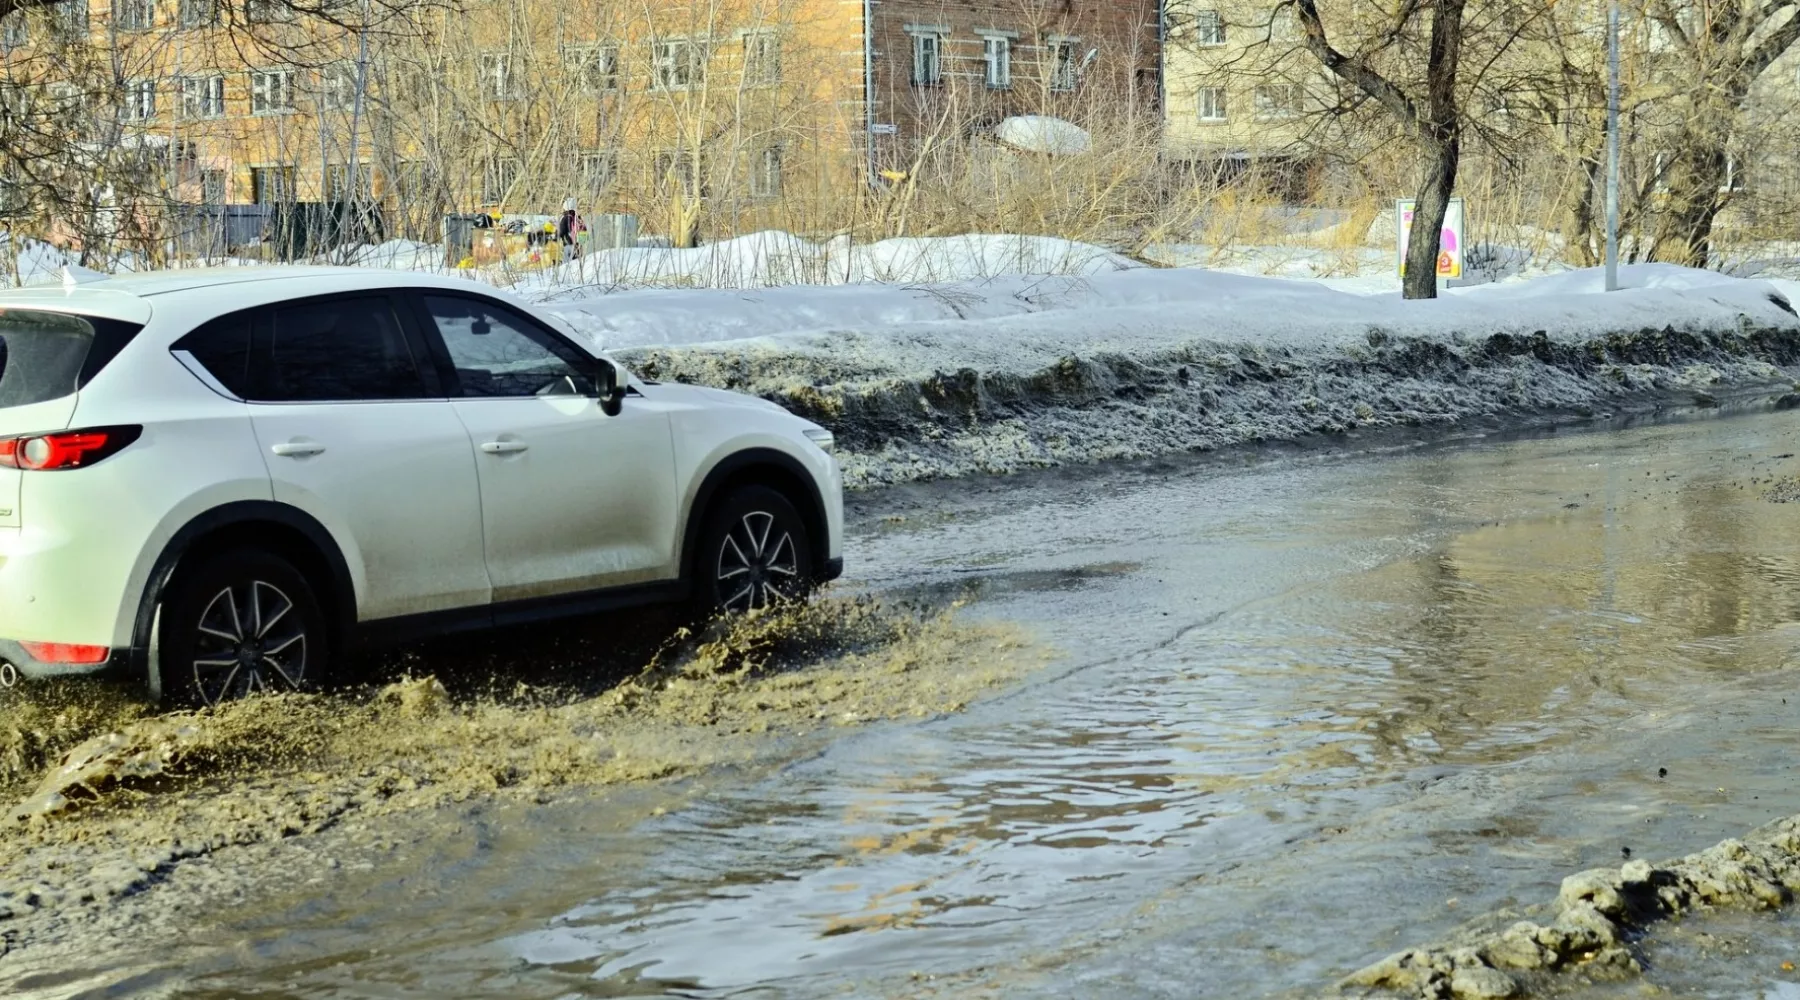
<box><xmin>149</xmin><ymin>549</ymin><xmax>331</xmax><ymax>707</ymax></box>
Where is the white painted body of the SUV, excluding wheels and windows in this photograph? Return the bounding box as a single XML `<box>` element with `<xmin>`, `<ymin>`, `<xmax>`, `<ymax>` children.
<box><xmin>0</xmin><ymin>268</ymin><xmax>842</xmax><ymax>687</ymax></box>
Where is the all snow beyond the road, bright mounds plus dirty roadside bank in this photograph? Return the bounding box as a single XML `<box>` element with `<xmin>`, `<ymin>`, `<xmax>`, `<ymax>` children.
<box><xmin>18</xmin><ymin>227</ymin><xmax>1800</xmax><ymax>486</ymax></box>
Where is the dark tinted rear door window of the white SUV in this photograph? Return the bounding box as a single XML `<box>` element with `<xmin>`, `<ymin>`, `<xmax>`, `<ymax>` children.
<box><xmin>264</xmin><ymin>295</ymin><xmax>428</xmax><ymax>403</ymax></box>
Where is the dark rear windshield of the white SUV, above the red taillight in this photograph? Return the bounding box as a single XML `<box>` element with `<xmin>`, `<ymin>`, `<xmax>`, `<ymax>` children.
<box><xmin>0</xmin><ymin>308</ymin><xmax>140</xmax><ymax>410</ymax></box>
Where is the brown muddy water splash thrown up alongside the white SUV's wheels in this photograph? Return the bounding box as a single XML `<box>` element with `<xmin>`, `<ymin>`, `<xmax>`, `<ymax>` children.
<box><xmin>0</xmin><ymin>599</ymin><xmax>1044</xmax><ymax>941</ymax></box>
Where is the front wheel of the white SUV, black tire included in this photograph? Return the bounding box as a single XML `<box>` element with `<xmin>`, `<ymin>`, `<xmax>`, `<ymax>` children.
<box><xmin>693</xmin><ymin>486</ymin><xmax>817</xmax><ymax>615</ymax></box>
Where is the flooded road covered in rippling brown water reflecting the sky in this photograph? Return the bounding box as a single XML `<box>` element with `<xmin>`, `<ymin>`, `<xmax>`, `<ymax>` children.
<box><xmin>17</xmin><ymin>412</ymin><xmax>1800</xmax><ymax>1000</ymax></box>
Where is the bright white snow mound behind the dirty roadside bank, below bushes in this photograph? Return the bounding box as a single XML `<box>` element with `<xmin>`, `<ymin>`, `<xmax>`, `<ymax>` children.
<box><xmin>513</xmin><ymin>232</ymin><xmax>1139</xmax><ymax>297</ymax></box>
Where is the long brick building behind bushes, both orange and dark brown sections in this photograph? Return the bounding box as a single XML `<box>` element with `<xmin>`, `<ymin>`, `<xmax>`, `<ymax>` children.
<box><xmin>0</xmin><ymin>0</ymin><xmax>1159</xmax><ymax>248</ymax></box>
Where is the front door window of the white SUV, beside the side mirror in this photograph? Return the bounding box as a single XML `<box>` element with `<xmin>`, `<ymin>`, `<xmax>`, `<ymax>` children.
<box><xmin>425</xmin><ymin>295</ymin><xmax>596</xmax><ymax>399</ymax></box>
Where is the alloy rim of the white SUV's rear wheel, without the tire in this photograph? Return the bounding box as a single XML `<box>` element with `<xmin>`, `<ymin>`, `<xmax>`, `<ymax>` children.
<box><xmin>193</xmin><ymin>579</ymin><xmax>306</xmax><ymax>705</ymax></box>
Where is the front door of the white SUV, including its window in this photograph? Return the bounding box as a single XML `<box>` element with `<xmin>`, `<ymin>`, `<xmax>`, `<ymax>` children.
<box><xmin>418</xmin><ymin>291</ymin><xmax>677</xmax><ymax>603</ymax></box>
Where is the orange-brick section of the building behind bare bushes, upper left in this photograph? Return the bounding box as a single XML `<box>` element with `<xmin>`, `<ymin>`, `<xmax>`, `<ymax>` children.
<box><xmin>0</xmin><ymin>0</ymin><xmax>862</xmax><ymax>235</ymax></box>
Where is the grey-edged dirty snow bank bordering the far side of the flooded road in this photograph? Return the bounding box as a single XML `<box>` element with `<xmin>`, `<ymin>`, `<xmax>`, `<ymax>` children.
<box><xmin>556</xmin><ymin>266</ymin><xmax>1800</xmax><ymax>487</ymax></box>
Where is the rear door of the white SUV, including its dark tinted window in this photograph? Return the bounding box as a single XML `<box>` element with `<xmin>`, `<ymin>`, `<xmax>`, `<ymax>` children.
<box><xmin>176</xmin><ymin>291</ymin><xmax>490</xmax><ymax>621</ymax></box>
